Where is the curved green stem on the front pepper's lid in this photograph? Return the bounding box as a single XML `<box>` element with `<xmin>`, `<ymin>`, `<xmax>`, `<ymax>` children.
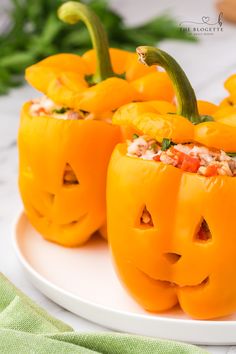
<box><xmin>136</xmin><ymin>46</ymin><xmax>202</xmax><ymax>124</ymax></box>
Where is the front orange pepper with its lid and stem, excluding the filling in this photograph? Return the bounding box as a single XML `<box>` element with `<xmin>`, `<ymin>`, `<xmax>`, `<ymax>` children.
<box><xmin>107</xmin><ymin>47</ymin><xmax>236</xmax><ymax>319</ymax></box>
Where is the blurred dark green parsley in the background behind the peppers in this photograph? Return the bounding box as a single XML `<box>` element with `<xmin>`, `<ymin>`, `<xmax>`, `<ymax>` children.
<box><xmin>0</xmin><ymin>0</ymin><xmax>196</xmax><ymax>94</ymax></box>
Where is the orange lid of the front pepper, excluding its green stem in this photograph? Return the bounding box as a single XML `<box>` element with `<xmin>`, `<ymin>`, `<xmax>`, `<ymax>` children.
<box><xmin>112</xmin><ymin>101</ymin><xmax>236</xmax><ymax>152</ymax></box>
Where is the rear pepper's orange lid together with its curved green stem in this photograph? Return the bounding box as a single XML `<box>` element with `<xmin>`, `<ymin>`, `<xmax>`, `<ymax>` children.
<box><xmin>26</xmin><ymin>1</ymin><xmax>174</xmax><ymax>114</ymax></box>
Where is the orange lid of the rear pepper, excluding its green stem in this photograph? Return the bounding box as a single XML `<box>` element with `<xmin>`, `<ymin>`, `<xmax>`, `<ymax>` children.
<box><xmin>26</xmin><ymin>48</ymin><xmax>174</xmax><ymax>114</ymax></box>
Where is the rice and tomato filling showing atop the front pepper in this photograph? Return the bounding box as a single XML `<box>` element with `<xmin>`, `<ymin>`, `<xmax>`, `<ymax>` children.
<box><xmin>127</xmin><ymin>134</ymin><xmax>236</xmax><ymax>177</ymax></box>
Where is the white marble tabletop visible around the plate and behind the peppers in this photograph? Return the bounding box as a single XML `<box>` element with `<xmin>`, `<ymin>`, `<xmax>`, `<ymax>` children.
<box><xmin>0</xmin><ymin>0</ymin><xmax>236</xmax><ymax>354</ymax></box>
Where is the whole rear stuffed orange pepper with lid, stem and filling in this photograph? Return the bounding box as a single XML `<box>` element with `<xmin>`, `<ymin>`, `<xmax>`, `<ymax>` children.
<box><xmin>18</xmin><ymin>2</ymin><xmax>174</xmax><ymax>246</ymax></box>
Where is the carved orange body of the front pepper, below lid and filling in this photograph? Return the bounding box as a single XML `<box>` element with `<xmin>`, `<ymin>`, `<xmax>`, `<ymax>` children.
<box><xmin>107</xmin><ymin>144</ymin><xmax>236</xmax><ymax>319</ymax></box>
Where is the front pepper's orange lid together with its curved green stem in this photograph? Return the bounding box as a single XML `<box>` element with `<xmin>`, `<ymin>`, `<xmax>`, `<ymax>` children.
<box><xmin>113</xmin><ymin>47</ymin><xmax>236</xmax><ymax>152</ymax></box>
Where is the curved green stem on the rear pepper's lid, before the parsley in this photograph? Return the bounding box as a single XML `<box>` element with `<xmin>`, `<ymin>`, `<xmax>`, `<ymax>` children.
<box><xmin>58</xmin><ymin>1</ymin><xmax>115</xmax><ymax>83</ymax></box>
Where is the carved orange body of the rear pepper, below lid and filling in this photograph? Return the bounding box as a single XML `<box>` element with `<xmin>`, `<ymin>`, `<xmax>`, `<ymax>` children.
<box><xmin>18</xmin><ymin>103</ymin><xmax>120</xmax><ymax>246</ymax></box>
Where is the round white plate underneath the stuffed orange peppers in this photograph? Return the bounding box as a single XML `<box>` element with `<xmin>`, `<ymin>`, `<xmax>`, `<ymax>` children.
<box><xmin>14</xmin><ymin>213</ymin><xmax>236</xmax><ymax>345</ymax></box>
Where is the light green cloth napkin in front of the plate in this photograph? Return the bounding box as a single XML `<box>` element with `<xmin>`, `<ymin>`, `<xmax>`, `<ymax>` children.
<box><xmin>0</xmin><ymin>274</ymin><xmax>207</xmax><ymax>354</ymax></box>
